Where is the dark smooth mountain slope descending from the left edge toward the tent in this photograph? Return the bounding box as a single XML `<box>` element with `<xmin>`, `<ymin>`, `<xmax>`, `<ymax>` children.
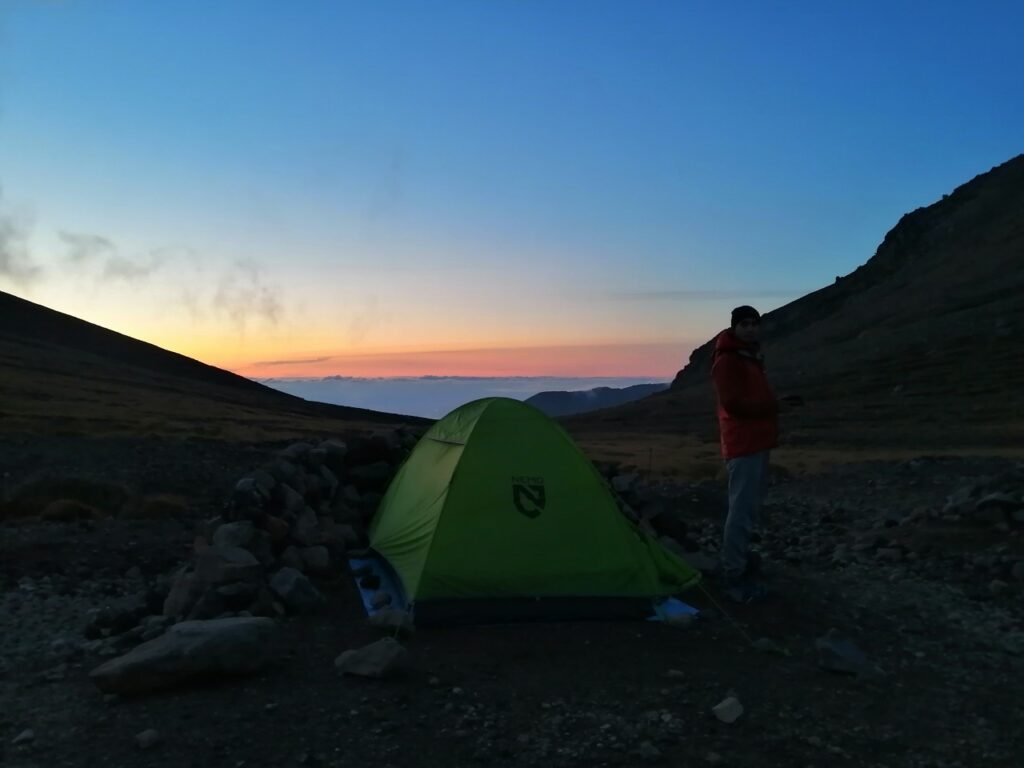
<box><xmin>0</xmin><ymin>292</ymin><xmax>420</xmax><ymax>436</ymax></box>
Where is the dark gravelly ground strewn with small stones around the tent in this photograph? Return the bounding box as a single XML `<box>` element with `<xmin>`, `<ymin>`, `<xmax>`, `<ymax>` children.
<box><xmin>0</xmin><ymin>438</ymin><xmax>1024</xmax><ymax>768</ymax></box>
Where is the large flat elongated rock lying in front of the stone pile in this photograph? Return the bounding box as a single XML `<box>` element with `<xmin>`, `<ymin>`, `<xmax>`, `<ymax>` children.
<box><xmin>89</xmin><ymin>618</ymin><xmax>278</xmax><ymax>693</ymax></box>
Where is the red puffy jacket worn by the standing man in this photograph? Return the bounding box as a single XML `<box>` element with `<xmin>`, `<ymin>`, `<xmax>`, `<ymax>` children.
<box><xmin>711</xmin><ymin>330</ymin><xmax>778</xmax><ymax>459</ymax></box>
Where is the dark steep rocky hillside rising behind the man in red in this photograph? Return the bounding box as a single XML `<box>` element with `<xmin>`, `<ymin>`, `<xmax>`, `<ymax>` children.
<box><xmin>571</xmin><ymin>156</ymin><xmax>1024</xmax><ymax>447</ymax></box>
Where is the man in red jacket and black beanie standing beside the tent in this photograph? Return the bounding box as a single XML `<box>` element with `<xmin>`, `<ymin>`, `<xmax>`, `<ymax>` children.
<box><xmin>712</xmin><ymin>305</ymin><xmax>782</xmax><ymax>602</ymax></box>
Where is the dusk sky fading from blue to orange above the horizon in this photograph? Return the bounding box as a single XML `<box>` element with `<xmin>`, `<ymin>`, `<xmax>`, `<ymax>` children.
<box><xmin>0</xmin><ymin>0</ymin><xmax>1024</xmax><ymax>378</ymax></box>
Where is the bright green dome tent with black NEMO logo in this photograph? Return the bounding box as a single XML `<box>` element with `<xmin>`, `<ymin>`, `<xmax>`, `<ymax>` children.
<box><xmin>370</xmin><ymin>397</ymin><xmax>699</xmax><ymax>624</ymax></box>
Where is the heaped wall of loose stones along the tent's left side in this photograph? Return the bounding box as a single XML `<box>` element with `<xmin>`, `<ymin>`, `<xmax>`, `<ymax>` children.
<box><xmin>78</xmin><ymin>429</ymin><xmax>417</xmax><ymax>655</ymax></box>
